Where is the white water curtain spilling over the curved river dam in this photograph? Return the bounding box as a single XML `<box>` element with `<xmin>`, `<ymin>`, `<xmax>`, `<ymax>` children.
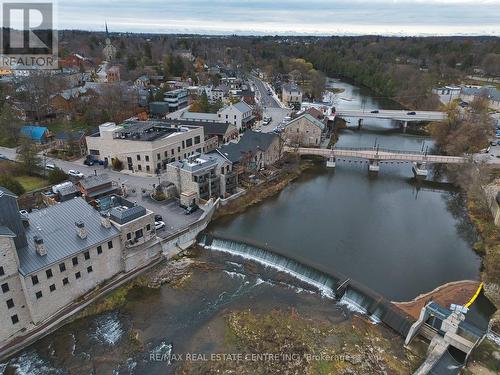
<box><xmin>200</xmin><ymin>236</ymin><xmax>337</xmax><ymax>299</ymax></box>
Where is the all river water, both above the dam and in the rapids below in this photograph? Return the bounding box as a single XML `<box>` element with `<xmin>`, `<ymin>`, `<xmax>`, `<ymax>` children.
<box><xmin>0</xmin><ymin>78</ymin><xmax>480</xmax><ymax>375</ymax></box>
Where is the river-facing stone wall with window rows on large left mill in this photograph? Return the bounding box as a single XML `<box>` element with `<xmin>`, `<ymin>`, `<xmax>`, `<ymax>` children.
<box><xmin>24</xmin><ymin>235</ymin><xmax>123</xmax><ymax>324</ymax></box>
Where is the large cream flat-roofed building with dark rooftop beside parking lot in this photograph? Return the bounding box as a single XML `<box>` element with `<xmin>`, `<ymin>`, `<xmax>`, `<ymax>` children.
<box><xmin>87</xmin><ymin>120</ymin><xmax>204</xmax><ymax>174</ymax></box>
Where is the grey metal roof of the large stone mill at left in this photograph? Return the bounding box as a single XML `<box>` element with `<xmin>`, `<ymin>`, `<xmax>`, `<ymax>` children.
<box><xmin>18</xmin><ymin>197</ymin><xmax>119</xmax><ymax>275</ymax></box>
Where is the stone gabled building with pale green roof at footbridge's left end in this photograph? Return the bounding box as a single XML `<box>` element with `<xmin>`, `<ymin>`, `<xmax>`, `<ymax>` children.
<box><xmin>283</xmin><ymin>113</ymin><xmax>326</xmax><ymax>147</ymax></box>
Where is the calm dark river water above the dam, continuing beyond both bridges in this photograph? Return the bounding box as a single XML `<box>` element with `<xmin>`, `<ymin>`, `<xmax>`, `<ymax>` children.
<box><xmin>211</xmin><ymin>82</ymin><xmax>480</xmax><ymax>301</ymax></box>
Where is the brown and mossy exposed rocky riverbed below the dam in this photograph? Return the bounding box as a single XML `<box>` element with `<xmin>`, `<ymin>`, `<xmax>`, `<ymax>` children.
<box><xmin>177</xmin><ymin>309</ymin><xmax>422</xmax><ymax>375</ymax></box>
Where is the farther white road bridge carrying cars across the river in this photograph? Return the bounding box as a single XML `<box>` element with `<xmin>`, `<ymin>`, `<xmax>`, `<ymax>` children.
<box><xmin>335</xmin><ymin>109</ymin><xmax>447</xmax><ymax>122</ymax></box>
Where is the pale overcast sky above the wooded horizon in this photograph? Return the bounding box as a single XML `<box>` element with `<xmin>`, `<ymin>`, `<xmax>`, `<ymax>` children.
<box><xmin>47</xmin><ymin>0</ymin><xmax>500</xmax><ymax>36</ymax></box>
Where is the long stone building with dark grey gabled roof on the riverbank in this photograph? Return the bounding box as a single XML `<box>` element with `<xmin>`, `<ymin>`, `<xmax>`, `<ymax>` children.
<box><xmin>217</xmin><ymin>130</ymin><xmax>282</xmax><ymax>172</ymax></box>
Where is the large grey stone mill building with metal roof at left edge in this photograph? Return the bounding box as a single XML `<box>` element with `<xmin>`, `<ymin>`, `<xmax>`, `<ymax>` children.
<box><xmin>0</xmin><ymin>187</ymin><xmax>160</xmax><ymax>346</ymax></box>
